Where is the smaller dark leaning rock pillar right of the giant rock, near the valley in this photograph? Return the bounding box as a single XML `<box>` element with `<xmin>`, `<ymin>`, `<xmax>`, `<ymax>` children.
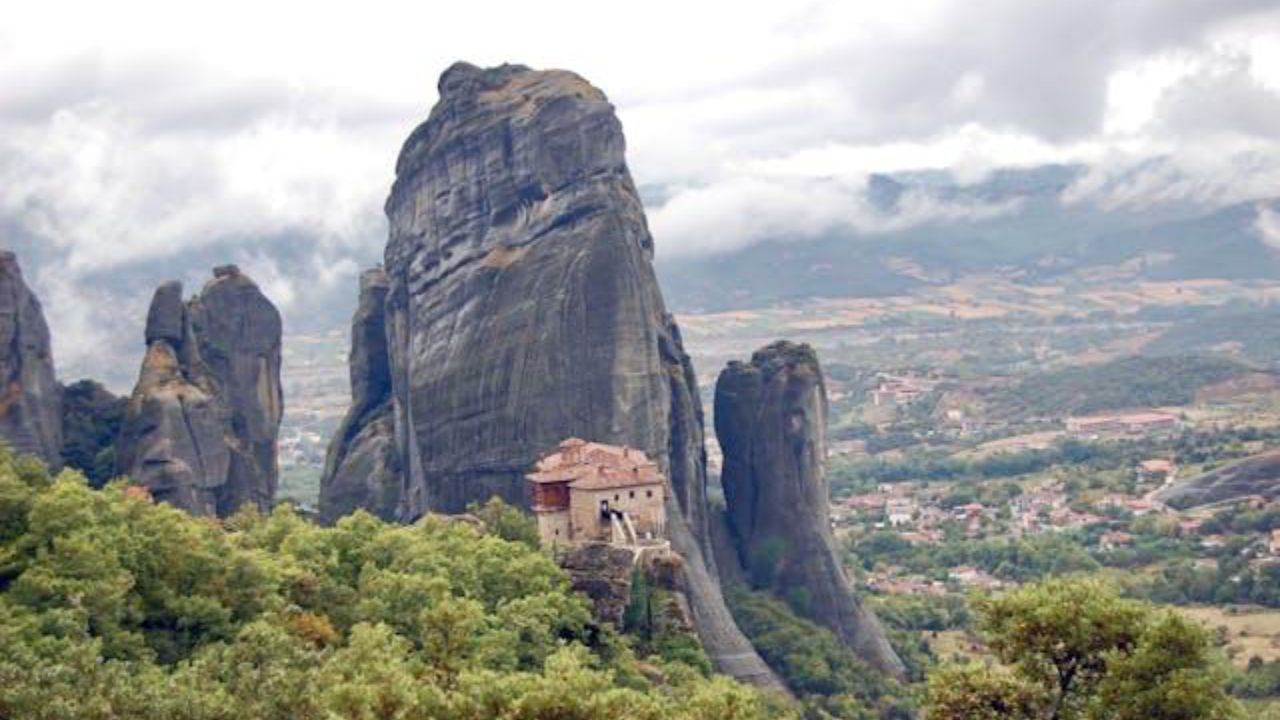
<box><xmin>716</xmin><ymin>341</ymin><xmax>904</xmax><ymax>676</ymax></box>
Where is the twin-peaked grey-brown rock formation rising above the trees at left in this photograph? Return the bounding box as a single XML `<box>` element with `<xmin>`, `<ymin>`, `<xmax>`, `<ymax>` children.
<box><xmin>116</xmin><ymin>266</ymin><xmax>283</xmax><ymax>515</ymax></box>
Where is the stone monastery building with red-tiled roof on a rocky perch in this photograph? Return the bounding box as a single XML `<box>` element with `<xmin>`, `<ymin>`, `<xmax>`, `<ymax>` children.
<box><xmin>526</xmin><ymin>438</ymin><xmax>667</xmax><ymax>544</ymax></box>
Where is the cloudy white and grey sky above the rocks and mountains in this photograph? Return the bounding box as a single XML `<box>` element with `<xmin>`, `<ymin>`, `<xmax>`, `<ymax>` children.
<box><xmin>0</xmin><ymin>0</ymin><xmax>1280</xmax><ymax>381</ymax></box>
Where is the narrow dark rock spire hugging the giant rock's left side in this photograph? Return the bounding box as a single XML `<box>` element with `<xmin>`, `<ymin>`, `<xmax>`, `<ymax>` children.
<box><xmin>320</xmin><ymin>269</ymin><xmax>403</xmax><ymax>523</ymax></box>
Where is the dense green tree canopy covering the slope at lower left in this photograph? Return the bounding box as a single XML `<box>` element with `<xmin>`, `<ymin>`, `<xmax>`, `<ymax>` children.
<box><xmin>0</xmin><ymin>452</ymin><xmax>790</xmax><ymax>720</ymax></box>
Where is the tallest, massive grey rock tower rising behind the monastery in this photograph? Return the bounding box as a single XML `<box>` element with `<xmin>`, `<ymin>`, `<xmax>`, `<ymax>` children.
<box><xmin>322</xmin><ymin>63</ymin><xmax>780</xmax><ymax>687</ymax></box>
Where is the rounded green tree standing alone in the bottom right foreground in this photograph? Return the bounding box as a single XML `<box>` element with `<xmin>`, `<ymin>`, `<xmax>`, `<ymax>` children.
<box><xmin>928</xmin><ymin>579</ymin><xmax>1240</xmax><ymax>720</ymax></box>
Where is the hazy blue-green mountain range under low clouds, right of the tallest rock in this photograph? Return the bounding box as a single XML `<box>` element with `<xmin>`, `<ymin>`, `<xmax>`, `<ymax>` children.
<box><xmin>658</xmin><ymin>165</ymin><xmax>1280</xmax><ymax>311</ymax></box>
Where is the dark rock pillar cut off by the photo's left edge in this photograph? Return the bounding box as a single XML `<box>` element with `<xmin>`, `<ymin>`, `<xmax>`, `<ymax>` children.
<box><xmin>0</xmin><ymin>251</ymin><xmax>63</xmax><ymax>466</ymax></box>
